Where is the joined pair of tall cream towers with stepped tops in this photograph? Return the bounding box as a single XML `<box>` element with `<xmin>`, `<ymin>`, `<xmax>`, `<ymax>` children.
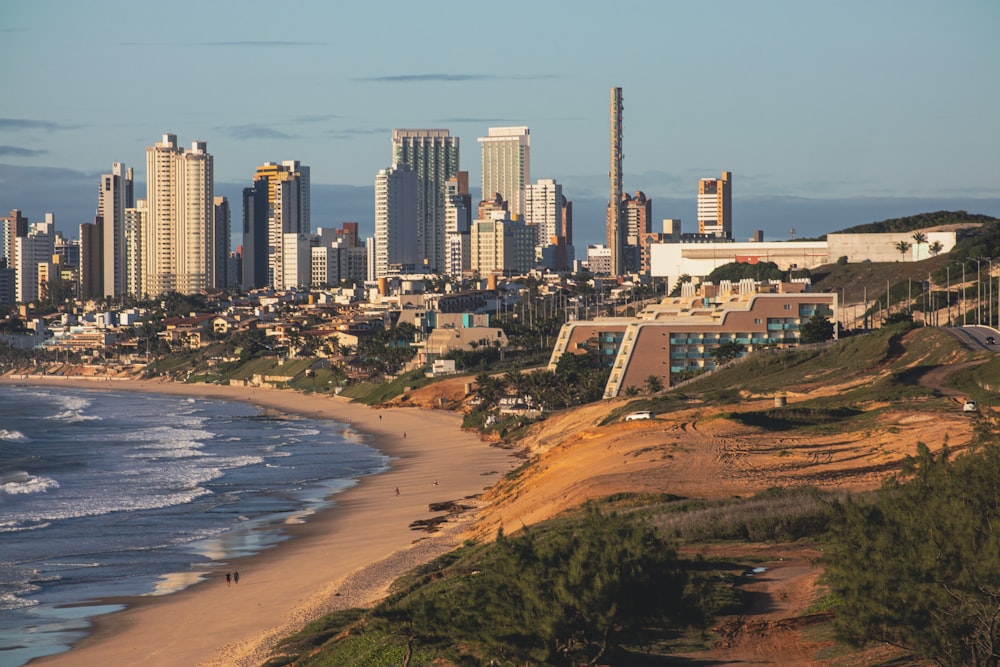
<box><xmin>142</xmin><ymin>134</ymin><xmax>215</xmax><ymax>295</ymax></box>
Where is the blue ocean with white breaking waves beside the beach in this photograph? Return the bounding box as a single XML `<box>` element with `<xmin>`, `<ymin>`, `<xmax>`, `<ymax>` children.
<box><xmin>0</xmin><ymin>385</ymin><xmax>388</xmax><ymax>667</ymax></box>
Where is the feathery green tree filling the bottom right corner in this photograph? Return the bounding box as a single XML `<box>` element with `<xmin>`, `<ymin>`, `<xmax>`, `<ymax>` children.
<box><xmin>825</xmin><ymin>443</ymin><xmax>1000</xmax><ymax>666</ymax></box>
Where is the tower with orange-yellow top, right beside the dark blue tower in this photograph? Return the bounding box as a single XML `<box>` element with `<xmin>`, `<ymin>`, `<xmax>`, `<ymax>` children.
<box><xmin>249</xmin><ymin>160</ymin><xmax>311</xmax><ymax>289</ymax></box>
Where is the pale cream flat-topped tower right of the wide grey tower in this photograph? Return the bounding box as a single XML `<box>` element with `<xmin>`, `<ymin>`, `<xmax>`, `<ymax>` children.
<box><xmin>479</xmin><ymin>127</ymin><xmax>531</xmax><ymax>217</ymax></box>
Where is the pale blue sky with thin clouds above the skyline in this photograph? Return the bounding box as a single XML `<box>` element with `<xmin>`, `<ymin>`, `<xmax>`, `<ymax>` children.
<box><xmin>0</xmin><ymin>0</ymin><xmax>1000</xmax><ymax>247</ymax></box>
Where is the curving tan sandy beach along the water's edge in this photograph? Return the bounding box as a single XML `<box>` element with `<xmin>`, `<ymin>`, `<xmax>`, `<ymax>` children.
<box><xmin>0</xmin><ymin>378</ymin><xmax>517</xmax><ymax>667</ymax></box>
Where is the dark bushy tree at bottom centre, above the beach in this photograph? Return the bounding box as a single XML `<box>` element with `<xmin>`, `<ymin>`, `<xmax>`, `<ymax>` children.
<box><xmin>394</xmin><ymin>509</ymin><xmax>700</xmax><ymax>665</ymax></box>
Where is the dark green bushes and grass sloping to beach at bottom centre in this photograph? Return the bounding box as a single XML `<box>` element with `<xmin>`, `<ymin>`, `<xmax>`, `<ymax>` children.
<box><xmin>269</xmin><ymin>509</ymin><xmax>720</xmax><ymax>667</ymax></box>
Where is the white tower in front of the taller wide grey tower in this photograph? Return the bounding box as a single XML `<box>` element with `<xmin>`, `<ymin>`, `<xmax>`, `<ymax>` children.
<box><xmin>374</xmin><ymin>164</ymin><xmax>420</xmax><ymax>278</ymax></box>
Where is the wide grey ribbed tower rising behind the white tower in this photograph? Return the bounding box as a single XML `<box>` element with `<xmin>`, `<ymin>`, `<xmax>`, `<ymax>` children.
<box><xmin>392</xmin><ymin>129</ymin><xmax>458</xmax><ymax>272</ymax></box>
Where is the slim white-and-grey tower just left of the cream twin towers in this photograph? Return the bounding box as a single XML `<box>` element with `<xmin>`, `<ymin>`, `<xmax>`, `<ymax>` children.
<box><xmin>97</xmin><ymin>162</ymin><xmax>135</xmax><ymax>297</ymax></box>
